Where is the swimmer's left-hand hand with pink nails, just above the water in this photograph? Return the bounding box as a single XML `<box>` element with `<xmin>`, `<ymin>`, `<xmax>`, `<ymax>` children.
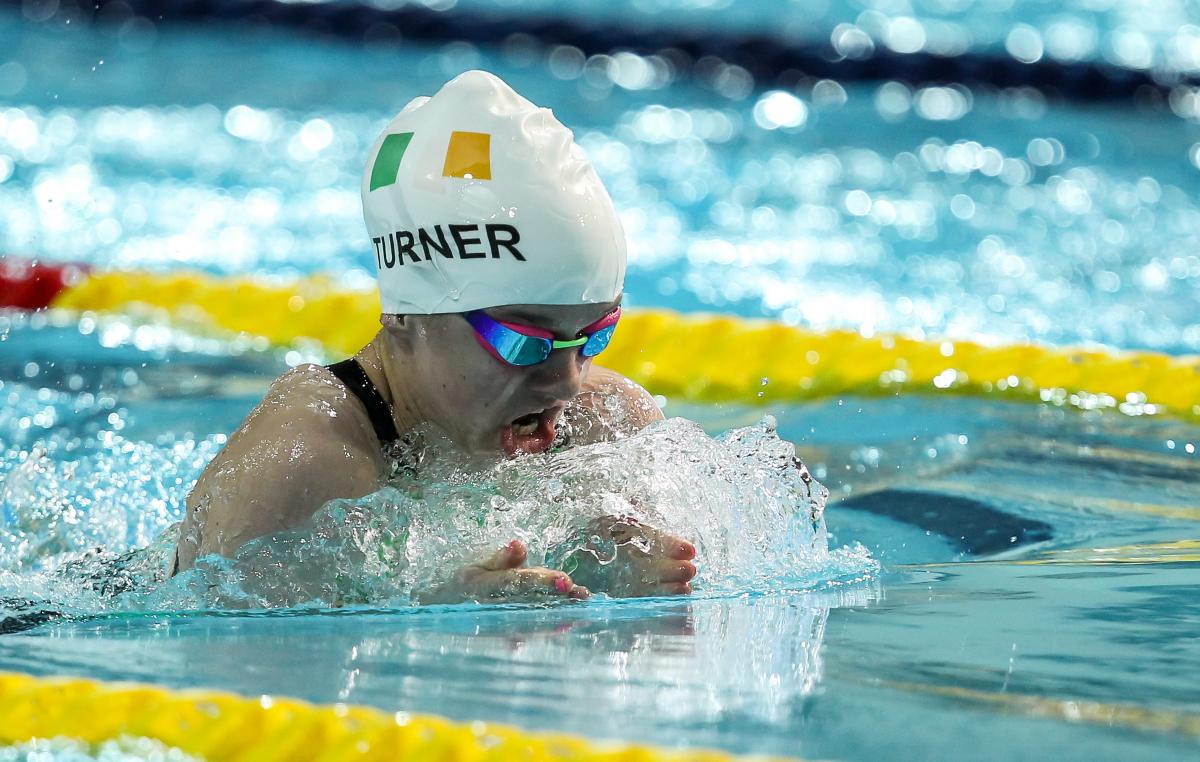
<box><xmin>415</xmin><ymin>540</ymin><xmax>592</xmax><ymax>605</ymax></box>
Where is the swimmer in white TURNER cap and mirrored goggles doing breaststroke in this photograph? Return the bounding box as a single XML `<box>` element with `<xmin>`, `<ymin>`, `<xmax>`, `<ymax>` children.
<box><xmin>175</xmin><ymin>71</ymin><xmax>696</xmax><ymax>602</ymax></box>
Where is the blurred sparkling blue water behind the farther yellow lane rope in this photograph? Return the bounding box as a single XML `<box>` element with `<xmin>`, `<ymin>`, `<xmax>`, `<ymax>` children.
<box><xmin>7</xmin><ymin>2</ymin><xmax>1200</xmax><ymax>352</ymax></box>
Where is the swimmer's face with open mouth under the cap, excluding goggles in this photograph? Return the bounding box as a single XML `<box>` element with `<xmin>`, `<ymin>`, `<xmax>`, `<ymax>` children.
<box><xmin>391</xmin><ymin>298</ymin><xmax>620</xmax><ymax>456</ymax></box>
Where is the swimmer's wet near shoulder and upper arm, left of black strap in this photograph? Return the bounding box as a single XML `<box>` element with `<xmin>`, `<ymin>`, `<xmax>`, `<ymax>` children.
<box><xmin>178</xmin><ymin>408</ymin><xmax>382</xmax><ymax>571</ymax></box>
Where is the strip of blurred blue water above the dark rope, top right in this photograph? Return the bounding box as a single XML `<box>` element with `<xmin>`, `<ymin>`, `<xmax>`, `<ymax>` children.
<box><xmin>441</xmin><ymin>0</ymin><xmax>1200</xmax><ymax>74</ymax></box>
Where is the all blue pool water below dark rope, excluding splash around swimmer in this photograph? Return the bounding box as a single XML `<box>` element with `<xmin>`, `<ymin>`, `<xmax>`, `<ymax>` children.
<box><xmin>0</xmin><ymin>5</ymin><xmax>1200</xmax><ymax>760</ymax></box>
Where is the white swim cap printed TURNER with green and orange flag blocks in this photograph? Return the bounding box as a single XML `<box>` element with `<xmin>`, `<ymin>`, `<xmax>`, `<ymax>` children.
<box><xmin>362</xmin><ymin>71</ymin><xmax>625</xmax><ymax>314</ymax></box>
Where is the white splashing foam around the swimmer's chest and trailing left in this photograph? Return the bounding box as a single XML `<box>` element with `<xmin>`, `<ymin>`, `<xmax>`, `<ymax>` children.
<box><xmin>0</xmin><ymin>408</ymin><xmax>878</xmax><ymax>619</ymax></box>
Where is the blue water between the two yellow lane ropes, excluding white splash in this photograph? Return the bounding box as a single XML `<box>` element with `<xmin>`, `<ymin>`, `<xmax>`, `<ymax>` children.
<box><xmin>0</xmin><ymin>323</ymin><xmax>1200</xmax><ymax>760</ymax></box>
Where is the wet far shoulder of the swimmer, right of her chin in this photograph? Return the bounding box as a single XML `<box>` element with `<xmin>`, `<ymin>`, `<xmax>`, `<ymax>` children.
<box><xmin>564</xmin><ymin>365</ymin><xmax>662</xmax><ymax>444</ymax></box>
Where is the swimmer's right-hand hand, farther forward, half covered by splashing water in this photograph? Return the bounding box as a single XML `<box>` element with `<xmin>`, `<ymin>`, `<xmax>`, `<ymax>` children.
<box><xmin>564</xmin><ymin>516</ymin><xmax>696</xmax><ymax>598</ymax></box>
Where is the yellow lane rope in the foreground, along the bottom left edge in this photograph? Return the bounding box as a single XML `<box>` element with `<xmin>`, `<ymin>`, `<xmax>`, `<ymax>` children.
<box><xmin>0</xmin><ymin>672</ymin><xmax>762</xmax><ymax>762</ymax></box>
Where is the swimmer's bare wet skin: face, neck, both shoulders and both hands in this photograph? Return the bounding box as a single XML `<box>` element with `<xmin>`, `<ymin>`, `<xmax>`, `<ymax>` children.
<box><xmin>176</xmin><ymin>302</ymin><xmax>696</xmax><ymax>602</ymax></box>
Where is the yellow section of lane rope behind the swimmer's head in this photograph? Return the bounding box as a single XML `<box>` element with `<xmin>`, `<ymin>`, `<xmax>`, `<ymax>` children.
<box><xmin>52</xmin><ymin>271</ymin><xmax>1200</xmax><ymax>420</ymax></box>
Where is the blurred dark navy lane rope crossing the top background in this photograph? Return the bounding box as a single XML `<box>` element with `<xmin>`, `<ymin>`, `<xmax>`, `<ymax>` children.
<box><xmin>7</xmin><ymin>0</ymin><xmax>1200</xmax><ymax>101</ymax></box>
